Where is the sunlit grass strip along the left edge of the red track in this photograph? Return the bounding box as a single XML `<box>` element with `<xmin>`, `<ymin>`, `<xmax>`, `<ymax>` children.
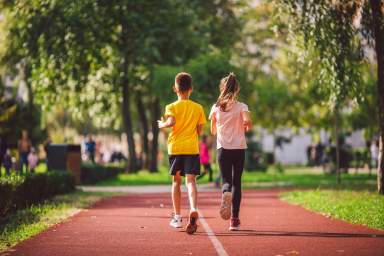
<box><xmin>0</xmin><ymin>191</ymin><xmax>118</xmax><ymax>252</ymax></box>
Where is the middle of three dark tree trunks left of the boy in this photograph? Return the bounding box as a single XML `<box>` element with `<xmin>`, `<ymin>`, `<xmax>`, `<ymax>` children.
<box><xmin>136</xmin><ymin>92</ymin><xmax>149</xmax><ymax>170</ymax></box>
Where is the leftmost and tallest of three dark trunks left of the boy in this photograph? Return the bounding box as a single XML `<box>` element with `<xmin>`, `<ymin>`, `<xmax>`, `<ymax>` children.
<box><xmin>121</xmin><ymin>61</ymin><xmax>137</xmax><ymax>172</ymax></box>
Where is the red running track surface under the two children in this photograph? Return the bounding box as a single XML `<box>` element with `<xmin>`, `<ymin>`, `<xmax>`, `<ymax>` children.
<box><xmin>1</xmin><ymin>191</ymin><xmax>384</xmax><ymax>256</ymax></box>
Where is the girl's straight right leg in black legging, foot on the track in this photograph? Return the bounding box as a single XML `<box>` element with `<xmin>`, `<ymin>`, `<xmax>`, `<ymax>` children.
<box><xmin>232</xmin><ymin>149</ymin><xmax>245</xmax><ymax>218</ymax></box>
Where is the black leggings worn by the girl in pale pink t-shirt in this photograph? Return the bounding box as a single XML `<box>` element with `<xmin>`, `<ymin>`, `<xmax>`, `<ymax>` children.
<box><xmin>217</xmin><ymin>148</ymin><xmax>245</xmax><ymax>218</ymax></box>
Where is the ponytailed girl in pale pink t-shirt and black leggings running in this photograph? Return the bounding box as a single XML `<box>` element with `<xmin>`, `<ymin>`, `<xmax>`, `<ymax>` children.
<box><xmin>209</xmin><ymin>73</ymin><xmax>252</xmax><ymax>230</ymax></box>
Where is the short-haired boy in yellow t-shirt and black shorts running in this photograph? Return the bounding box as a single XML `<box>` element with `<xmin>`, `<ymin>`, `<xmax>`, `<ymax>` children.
<box><xmin>159</xmin><ymin>72</ymin><xmax>206</xmax><ymax>234</ymax></box>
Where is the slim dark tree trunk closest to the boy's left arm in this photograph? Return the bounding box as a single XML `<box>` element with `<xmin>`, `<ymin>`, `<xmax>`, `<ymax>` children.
<box><xmin>149</xmin><ymin>97</ymin><xmax>161</xmax><ymax>172</ymax></box>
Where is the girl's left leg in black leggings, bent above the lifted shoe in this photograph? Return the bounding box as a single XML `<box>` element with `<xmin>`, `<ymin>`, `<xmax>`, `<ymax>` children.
<box><xmin>217</xmin><ymin>148</ymin><xmax>232</xmax><ymax>193</ymax></box>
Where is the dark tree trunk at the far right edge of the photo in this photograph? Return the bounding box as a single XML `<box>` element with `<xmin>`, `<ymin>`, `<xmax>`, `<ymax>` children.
<box><xmin>370</xmin><ymin>0</ymin><xmax>384</xmax><ymax>195</ymax></box>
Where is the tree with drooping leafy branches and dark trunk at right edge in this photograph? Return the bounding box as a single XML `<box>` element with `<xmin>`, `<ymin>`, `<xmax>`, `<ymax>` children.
<box><xmin>280</xmin><ymin>0</ymin><xmax>384</xmax><ymax>193</ymax></box>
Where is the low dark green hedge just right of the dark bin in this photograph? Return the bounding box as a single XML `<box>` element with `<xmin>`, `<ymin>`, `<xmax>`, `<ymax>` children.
<box><xmin>81</xmin><ymin>163</ymin><xmax>124</xmax><ymax>185</ymax></box>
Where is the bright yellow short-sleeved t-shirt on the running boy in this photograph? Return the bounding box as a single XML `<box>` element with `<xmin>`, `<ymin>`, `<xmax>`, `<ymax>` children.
<box><xmin>165</xmin><ymin>100</ymin><xmax>207</xmax><ymax>155</ymax></box>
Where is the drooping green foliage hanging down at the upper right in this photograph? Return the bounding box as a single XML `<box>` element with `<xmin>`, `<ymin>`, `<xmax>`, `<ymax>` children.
<box><xmin>281</xmin><ymin>0</ymin><xmax>363</xmax><ymax>108</ymax></box>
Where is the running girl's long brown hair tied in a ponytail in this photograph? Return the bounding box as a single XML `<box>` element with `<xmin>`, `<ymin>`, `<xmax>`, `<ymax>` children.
<box><xmin>216</xmin><ymin>72</ymin><xmax>240</xmax><ymax>111</ymax></box>
